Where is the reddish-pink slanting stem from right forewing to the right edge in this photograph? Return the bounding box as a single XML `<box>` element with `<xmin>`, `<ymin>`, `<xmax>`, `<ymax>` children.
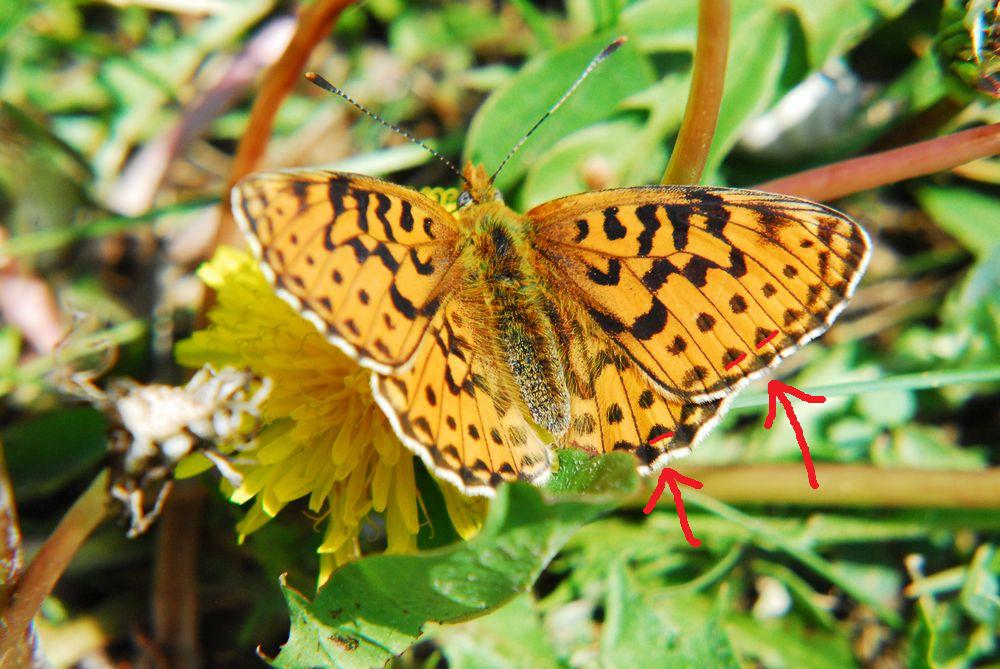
<box><xmin>753</xmin><ymin>123</ymin><xmax>1000</xmax><ymax>201</ymax></box>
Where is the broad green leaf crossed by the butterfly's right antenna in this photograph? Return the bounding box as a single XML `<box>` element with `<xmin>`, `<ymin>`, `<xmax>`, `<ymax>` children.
<box><xmin>465</xmin><ymin>32</ymin><xmax>653</xmax><ymax>191</ymax></box>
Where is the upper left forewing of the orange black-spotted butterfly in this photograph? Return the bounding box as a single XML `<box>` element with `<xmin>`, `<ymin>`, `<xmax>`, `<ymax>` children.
<box><xmin>232</xmin><ymin>170</ymin><xmax>458</xmax><ymax>373</ymax></box>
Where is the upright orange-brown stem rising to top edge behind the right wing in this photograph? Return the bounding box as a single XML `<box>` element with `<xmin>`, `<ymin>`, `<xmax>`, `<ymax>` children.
<box><xmin>660</xmin><ymin>0</ymin><xmax>730</xmax><ymax>184</ymax></box>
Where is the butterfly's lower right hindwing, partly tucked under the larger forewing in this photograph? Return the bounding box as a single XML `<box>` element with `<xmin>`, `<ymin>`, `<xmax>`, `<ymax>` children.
<box><xmin>554</xmin><ymin>303</ymin><xmax>730</xmax><ymax>475</ymax></box>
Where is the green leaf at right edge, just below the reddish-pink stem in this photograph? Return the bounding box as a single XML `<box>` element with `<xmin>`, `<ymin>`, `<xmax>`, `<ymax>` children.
<box><xmin>916</xmin><ymin>185</ymin><xmax>1000</xmax><ymax>258</ymax></box>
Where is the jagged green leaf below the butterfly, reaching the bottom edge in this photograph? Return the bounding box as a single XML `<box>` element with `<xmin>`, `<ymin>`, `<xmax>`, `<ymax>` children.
<box><xmin>273</xmin><ymin>483</ymin><xmax>611</xmax><ymax>668</ymax></box>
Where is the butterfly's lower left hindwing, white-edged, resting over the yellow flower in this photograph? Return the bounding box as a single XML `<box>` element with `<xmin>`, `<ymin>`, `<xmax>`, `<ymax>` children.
<box><xmin>372</xmin><ymin>299</ymin><xmax>551</xmax><ymax>495</ymax></box>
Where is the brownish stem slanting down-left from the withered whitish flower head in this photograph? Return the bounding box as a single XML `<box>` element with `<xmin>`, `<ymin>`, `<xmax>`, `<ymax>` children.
<box><xmin>0</xmin><ymin>470</ymin><xmax>108</xmax><ymax>658</ymax></box>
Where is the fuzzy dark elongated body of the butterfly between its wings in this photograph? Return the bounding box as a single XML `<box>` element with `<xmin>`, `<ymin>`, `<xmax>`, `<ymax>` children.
<box><xmin>458</xmin><ymin>193</ymin><xmax>569</xmax><ymax>435</ymax></box>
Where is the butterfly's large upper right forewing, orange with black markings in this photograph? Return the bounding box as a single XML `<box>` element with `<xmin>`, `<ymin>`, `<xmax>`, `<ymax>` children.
<box><xmin>527</xmin><ymin>186</ymin><xmax>868</xmax><ymax>402</ymax></box>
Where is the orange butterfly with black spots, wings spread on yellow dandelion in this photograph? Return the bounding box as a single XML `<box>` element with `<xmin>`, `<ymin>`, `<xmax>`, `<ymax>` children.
<box><xmin>232</xmin><ymin>163</ymin><xmax>869</xmax><ymax>495</ymax></box>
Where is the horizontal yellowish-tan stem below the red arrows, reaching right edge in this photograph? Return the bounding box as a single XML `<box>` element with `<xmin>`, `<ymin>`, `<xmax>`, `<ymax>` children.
<box><xmin>629</xmin><ymin>463</ymin><xmax>1000</xmax><ymax>510</ymax></box>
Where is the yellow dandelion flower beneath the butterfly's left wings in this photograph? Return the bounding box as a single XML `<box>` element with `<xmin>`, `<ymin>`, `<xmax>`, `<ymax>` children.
<box><xmin>176</xmin><ymin>248</ymin><xmax>485</xmax><ymax>582</ymax></box>
